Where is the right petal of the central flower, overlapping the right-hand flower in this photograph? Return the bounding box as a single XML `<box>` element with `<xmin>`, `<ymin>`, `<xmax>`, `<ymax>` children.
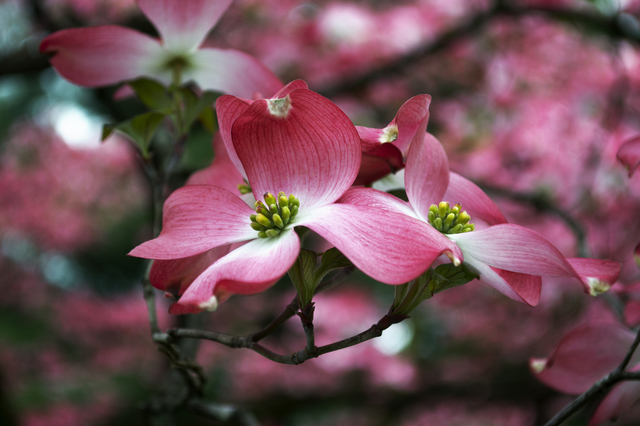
<box><xmin>295</xmin><ymin>204</ymin><xmax>462</xmax><ymax>284</ymax></box>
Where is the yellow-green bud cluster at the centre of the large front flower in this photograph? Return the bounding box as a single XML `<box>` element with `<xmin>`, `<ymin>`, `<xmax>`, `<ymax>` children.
<box><xmin>249</xmin><ymin>191</ymin><xmax>300</xmax><ymax>238</ymax></box>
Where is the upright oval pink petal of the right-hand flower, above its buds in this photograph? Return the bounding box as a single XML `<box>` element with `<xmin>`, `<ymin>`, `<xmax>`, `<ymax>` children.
<box><xmin>404</xmin><ymin>133</ymin><xmax>449</xmax><ymax>221</ymax></box>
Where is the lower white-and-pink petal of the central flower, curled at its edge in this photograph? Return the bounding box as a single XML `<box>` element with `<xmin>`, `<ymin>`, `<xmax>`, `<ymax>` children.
<box><xmin>170</xmin><ymin>229</ymin><xmax>300</xmax><ymax>313</ymax></box>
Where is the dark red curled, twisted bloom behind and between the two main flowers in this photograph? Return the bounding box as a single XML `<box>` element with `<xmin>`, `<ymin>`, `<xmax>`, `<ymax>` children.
<box><xmin>354</xmin><ymin>95</ymin><xmax>431</xmax><ymax>185</ymax></box>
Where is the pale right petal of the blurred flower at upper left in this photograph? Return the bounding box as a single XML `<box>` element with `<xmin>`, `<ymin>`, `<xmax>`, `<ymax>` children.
<box><xmin>184</xmin><ymin>48</ymin><xmax>282</xmax><ymax>98</ymax></box>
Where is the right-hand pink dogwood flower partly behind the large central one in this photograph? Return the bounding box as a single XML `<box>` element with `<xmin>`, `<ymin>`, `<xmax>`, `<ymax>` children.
<box><xmin>339</xmin><ymin>133</ymin><xmax>620</xmax><ymax>306</ymax></box>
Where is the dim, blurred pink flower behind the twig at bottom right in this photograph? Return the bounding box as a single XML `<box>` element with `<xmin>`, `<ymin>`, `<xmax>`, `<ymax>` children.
<box><xmin>529</xmin><ymin>322</ymin><xmax>640</xmax><ymax>426</ymax></box>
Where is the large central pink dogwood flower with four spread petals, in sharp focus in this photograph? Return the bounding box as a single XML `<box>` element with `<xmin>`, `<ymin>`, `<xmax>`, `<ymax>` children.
<box><xmin>130</xmin><ymin>86</ymin><xmax>462</xmax><ymax>314</ymax></box>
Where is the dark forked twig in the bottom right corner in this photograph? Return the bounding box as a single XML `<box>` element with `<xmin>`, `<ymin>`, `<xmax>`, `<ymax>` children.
<box><xmin>545</xmin><ymin>330</ymin><xmax>640</xmax><ymax>426</ymax></box>
